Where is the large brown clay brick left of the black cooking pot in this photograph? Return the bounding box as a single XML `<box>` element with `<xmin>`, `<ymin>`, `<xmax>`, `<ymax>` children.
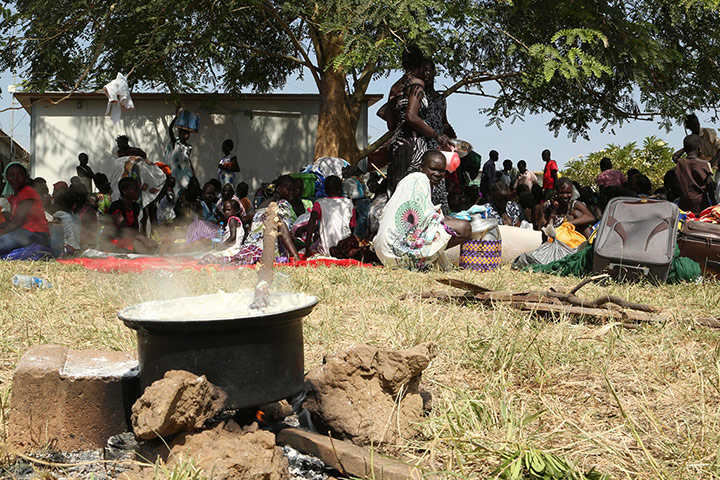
<box><xmin>8</xmin><ymin>345</ymin><xmax>139</xmax><ymax>452</ymax></box>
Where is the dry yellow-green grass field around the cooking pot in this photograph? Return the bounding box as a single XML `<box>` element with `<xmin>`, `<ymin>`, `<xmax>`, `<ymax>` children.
<box><xmin>0</xmin><ymin>262</ymin><xmax>720</xmax><ymax>479</ymax></box>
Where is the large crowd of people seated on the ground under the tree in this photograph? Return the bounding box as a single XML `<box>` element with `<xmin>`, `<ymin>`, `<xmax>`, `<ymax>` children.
<box><xmin>0</xmin><ymin>114</ymin><xmax>717</xmax><ymax>268</ymax></box>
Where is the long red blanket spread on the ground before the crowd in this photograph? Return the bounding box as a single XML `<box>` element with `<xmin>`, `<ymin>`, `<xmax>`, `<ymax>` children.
<box><xmin>58</xmin><ymin>257</ymin><xmax>373</xmax><ymax>273</ymax></box>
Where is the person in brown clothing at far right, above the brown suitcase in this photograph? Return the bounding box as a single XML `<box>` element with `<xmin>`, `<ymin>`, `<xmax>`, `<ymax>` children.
<box><xmin>675</xmin><ymin>134</ymin><xmax>714</xmax><ymax>215</ymax></box>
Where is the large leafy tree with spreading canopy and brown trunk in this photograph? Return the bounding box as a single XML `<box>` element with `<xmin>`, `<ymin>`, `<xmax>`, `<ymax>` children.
<box><xmin>0</xmin><ymin>0</ymin><xmax>720</xmax><ymax>160</ymax></box>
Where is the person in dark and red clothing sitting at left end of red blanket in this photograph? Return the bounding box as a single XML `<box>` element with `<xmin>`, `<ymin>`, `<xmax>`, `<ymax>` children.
<box><xmin>103</xmin><ymin>177</ymin><xmax>158</xmax><ymax>254</ymax></box>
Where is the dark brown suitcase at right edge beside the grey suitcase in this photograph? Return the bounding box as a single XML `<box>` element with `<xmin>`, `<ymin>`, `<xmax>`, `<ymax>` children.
<box><xmin>678</xmin><ymin>221</ymin><xmax>720</xmax><ymax>278</ymax></box>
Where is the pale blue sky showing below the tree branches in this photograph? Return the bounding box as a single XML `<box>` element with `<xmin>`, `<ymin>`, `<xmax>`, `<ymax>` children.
<box><xmin>0</xmin><ymin>66</ymin><xmax>696</xmax><ymax>170</ymax></box>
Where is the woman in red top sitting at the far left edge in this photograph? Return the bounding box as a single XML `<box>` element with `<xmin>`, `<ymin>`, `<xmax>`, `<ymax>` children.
<box><xmin>0</xmin><ymin>162</ymin><xmax>50</xmax><ymax>255</ymax></box>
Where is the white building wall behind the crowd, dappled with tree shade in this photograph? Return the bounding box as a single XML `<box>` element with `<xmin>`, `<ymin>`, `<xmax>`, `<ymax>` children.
<box><xmin>26</xmin><ymin>96</ymin><xmax>367</xmax><ymax>192</ymax></box>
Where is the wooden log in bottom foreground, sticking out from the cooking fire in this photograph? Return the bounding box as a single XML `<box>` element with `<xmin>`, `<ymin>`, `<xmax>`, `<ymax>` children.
<box><xmin>277</xmin><ymin>428</ymin><xmax>428</xmax><ymax>480</ymax></box>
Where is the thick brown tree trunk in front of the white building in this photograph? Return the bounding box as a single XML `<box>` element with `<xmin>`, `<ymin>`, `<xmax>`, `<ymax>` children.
<box><xmin>315</xmin><ymin>35</ymin><xmax>359</xmax><ymax>165</ymax></box>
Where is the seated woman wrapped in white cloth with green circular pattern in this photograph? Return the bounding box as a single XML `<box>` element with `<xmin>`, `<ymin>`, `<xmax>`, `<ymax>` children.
<box><xmin>373</xmin><ymin>150</ymin><xmax>472</xmax><ymax>269</ymax></box>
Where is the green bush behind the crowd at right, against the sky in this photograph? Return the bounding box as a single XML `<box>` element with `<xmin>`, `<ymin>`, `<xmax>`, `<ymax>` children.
<box><xmin>561</xmin><ymin>136</ymin><xmax>675</xmax><ymax>189</ymax></box>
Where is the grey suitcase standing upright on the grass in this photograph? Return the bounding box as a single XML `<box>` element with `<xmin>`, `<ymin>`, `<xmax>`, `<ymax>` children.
<box><xmin>593</xmin><ymin>197</ymin><xmax>680</xmax><ymax>281</ymax></box>
